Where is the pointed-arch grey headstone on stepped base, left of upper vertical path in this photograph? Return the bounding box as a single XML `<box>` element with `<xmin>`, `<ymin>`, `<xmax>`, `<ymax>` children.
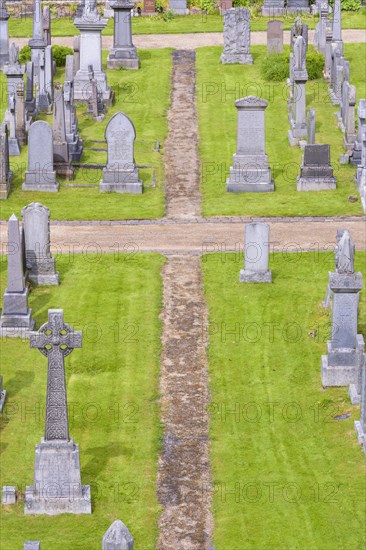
<box><xmin>100</xmin><ymin>112</ymin><xmax>142</xmax><ymax>194</ymax></box>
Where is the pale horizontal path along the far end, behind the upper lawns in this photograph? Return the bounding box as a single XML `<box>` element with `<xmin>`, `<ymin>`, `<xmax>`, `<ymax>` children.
<box><xmin>10</xmin><ymin>29</ymin><xmax>366</xmax><ymax>50</ymax></box>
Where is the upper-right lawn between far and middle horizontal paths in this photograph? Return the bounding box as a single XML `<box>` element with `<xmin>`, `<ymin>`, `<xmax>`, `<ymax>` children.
<box><xmin>197</xmin><ymin>44</ymin><xmax>366</xmax><ymax>216</ymax></box>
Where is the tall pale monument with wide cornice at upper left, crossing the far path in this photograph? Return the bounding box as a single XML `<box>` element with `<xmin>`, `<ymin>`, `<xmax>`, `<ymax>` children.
<box><xmin>74</xmin><ymin>0</ymin><xmax>113</xmax><ymax>102</ymax></box>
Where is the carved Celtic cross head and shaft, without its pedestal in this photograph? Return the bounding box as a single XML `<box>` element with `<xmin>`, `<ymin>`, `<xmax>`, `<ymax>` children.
<box><xmin>30</xmin><ymin>309</ymin><xmax>82</xmax><ymax>441</ymax></box>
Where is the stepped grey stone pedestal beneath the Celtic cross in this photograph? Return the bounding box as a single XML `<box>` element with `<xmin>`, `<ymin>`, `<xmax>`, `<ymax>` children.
<box><xmin>24</xmin><ymin>438</ymin><xmax>91</xmax><ymax>516</ymax></box>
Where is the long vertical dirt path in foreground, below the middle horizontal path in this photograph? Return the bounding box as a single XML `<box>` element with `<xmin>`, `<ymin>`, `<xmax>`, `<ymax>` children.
<box><xmin>158</xmin><ymin>256</ymin><xmax>213</xmax><ymax>550</ymax></box>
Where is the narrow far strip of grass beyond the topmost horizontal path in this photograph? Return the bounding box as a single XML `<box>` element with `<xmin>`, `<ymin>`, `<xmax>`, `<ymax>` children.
<box><xmin>9</xmin><ymin>8</ymin><xmax>366</xmax><ymax>38</ymax></box>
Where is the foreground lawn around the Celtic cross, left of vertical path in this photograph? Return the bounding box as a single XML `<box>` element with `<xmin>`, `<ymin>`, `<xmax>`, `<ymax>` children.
<box><xmin>0</xmin><ymin>254</ymin><xmax>164</xmax><ymax>550</ymax></box>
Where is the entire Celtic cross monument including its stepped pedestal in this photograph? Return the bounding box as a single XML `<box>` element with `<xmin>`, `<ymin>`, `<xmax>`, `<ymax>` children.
<box><xmin>24</xmin><ymin>309</ymin><xmax>91</xmax><ymax>515</ymax></box>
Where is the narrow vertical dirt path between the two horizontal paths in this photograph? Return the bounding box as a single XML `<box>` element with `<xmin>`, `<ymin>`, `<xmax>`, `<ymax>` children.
<box><xmin>164</xmin><ymin>50</ymin><xmax>201</xmax><ymax>219</ymax></box>
